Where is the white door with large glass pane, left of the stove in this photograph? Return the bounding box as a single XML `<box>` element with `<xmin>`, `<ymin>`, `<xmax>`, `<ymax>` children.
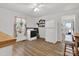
<box><xmin>14</xmin><ymin>17</ymin><xmax>26</xmax><ymax>41</ymax></box>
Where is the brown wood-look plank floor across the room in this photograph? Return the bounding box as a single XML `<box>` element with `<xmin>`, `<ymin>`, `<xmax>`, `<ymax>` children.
<box><xmin>13</xmin><ymin>39</ymin><xmax>72</xmax><ymax>56</ymax></box>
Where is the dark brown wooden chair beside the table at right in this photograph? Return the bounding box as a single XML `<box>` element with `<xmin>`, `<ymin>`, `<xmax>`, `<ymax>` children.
<box><xmin>64</xmin><ymin>35</ymin><xmax>75</xmax><ymax>56</ymax></box>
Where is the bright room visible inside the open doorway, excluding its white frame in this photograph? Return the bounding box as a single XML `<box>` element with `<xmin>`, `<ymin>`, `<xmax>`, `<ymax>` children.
<box><xmin>64</xmin><ymin>21</ymin><xmax>74</xmax><ymax>41</ymax></box>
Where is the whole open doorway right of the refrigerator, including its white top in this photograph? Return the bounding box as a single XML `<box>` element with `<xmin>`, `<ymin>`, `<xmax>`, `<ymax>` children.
<box><xmin>61</xmin><ymin>17</ymin><xmax>74</xmax><ymax>41</ymax></box>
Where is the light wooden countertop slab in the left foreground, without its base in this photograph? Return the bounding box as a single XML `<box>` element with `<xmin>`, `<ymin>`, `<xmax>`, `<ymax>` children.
<box><xmin>0</xmin><ymin>32</ymin><xmax>16</xmax><ymax>48</ymax></box>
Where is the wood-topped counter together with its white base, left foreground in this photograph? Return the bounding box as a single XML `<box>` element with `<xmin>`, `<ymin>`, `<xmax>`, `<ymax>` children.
<box><xmin>0</xmin><ymin>32</ymin><xmax>16</xmax><ymax>56</ymax></box>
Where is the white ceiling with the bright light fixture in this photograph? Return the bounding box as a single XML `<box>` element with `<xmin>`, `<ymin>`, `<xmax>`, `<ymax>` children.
<box><xmin>0</xmin><ymin>3</ymin><xmax>79</xmax><ymax>17</ymax></box>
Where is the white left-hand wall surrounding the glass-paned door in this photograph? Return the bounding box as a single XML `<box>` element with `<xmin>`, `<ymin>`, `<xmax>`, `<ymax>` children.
<box><xmin>0</xmin><ymin>8</ymin><xmax>35</xmax><ymax>35</ymax></box>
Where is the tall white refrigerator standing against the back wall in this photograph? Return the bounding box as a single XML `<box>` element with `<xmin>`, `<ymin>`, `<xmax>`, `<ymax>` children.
<box><xmin>45</xmin><ymin>20</ymin><xmax>57</xmax><ymax>43</ymax></box>
